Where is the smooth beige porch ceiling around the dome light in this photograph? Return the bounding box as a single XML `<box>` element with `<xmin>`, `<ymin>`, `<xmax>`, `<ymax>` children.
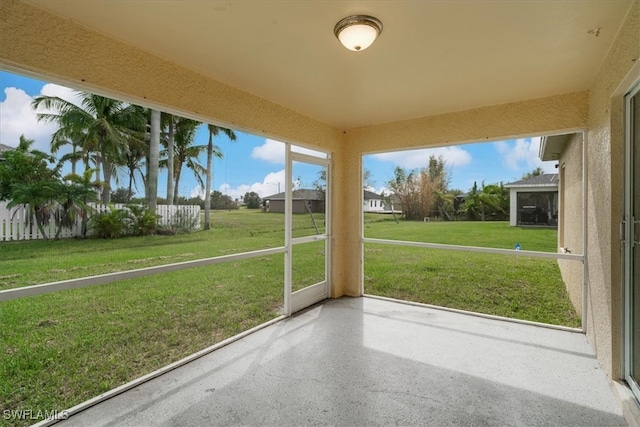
<box><xmin>28</xmin><ymin>0</ymin><xmax>632</xmax><ymax>129</ymax></box>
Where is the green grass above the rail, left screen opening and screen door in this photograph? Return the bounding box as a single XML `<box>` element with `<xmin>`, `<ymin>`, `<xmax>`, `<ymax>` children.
<box><xmin>0</xmin><ymin>209</ymin><xmax>324</xmax><ymax>290</ymax></box>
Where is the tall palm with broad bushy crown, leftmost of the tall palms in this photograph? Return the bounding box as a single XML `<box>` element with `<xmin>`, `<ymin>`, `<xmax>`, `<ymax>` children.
<box><xmin>31</xmin><ymin>92</ymin><xmax>146</xmax><ymax>203</ymax></box>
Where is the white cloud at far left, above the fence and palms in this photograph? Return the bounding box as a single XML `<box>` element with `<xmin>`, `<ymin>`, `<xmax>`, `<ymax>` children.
<box><xmin>0</xmin><ymin>84</ymin><xmax>78</xmax><ymax>152</ymax></box>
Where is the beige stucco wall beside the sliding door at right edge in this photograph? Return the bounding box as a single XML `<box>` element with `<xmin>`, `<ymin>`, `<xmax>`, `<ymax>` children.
<box><xmin>586</xmin><ymin>1</ymin><xmax>640</xmax><ymax>378</ymax></box>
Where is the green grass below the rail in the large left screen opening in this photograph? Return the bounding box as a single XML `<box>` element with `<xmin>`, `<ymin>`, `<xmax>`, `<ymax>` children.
<box><xmin>0</xmin><ymin>255</ymin><xmax>283</xmax><ymax>425</ymax></box>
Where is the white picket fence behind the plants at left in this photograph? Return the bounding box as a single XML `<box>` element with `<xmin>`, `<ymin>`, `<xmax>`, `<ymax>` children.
<box><xmin>0</xmin><ymin>202</ymin><xmax>200</xmax><ymax>242</ymax></box>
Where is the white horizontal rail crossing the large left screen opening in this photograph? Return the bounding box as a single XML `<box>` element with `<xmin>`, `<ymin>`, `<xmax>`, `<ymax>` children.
<box><xmin>0</xmin><ymin>246</ymin><xmax>286</xmax><ymax>302</ymax></box>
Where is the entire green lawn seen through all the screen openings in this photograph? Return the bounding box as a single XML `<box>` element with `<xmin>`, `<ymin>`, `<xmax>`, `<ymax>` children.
<box><xmin>0</xmin><ymin>210</ymin><xmax>580</xmax><ymax>425</ymax></box>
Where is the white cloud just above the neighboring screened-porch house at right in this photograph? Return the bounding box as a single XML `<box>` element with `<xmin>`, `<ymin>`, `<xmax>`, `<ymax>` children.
<box><xmin>493</xmin><ymin>137</ymin><xmax>556</xmax><ymax>173</ymax></box>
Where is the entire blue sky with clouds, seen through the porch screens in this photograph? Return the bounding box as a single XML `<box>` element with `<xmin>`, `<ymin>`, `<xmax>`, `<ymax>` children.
<box><xmin>0</xmin><ymin>71</ymin><xmax>555</xmax><ymax>198</ymax></box>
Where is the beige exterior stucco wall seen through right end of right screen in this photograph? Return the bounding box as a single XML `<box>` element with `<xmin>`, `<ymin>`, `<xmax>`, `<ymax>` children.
<box><xmin>558</xmin><ymin>133</ymin><xmax>584</xmax><ymax>316</ymax></box>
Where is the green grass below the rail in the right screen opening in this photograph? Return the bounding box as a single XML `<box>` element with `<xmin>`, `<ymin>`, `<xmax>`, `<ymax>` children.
<box><xmin>364</xmin><ymin>243</ymin><xmax>580</xmax><ymax>327</ymax></box>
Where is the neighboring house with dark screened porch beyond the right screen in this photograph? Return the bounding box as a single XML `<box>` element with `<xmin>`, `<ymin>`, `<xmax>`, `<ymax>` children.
<box><xmin>505</xmin><ymin>173</ymin><xmax>558</xmax><ymax>226</ymax></box>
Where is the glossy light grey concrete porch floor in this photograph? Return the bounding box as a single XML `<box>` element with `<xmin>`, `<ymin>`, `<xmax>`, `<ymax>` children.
<box><xmin>61</xmin><ymin>298</ymin><xmax>627</xmax><ymax>427</ymax></box>
